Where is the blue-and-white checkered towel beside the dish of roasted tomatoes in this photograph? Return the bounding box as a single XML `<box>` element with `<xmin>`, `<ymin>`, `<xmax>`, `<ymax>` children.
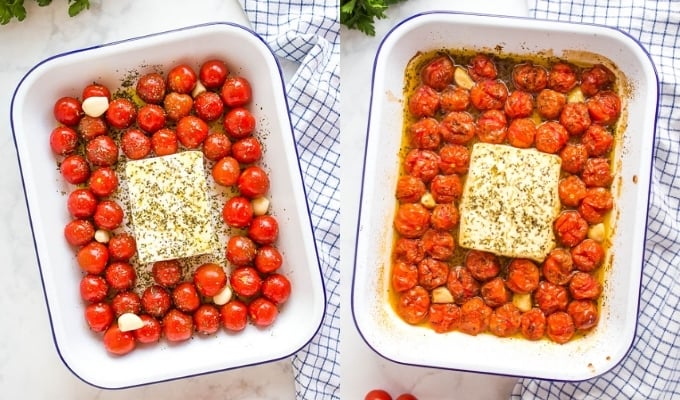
<box><xmin>512</xmin><ymin>0</ymin><xmax>680</xmax><ymax>400</ymax></box>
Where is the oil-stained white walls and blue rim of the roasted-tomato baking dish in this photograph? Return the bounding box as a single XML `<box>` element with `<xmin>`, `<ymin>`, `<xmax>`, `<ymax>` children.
<box><xmin>352</xmin><ymin>12</ymin><xmax>658</xmax><ymax>380</ymax></box>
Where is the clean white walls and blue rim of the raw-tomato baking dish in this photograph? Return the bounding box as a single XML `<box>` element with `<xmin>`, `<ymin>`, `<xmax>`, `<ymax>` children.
<box><xmin>11</xmin><ymin>23</ymin><xmax>325</xmax><ymax>388</ymax></box>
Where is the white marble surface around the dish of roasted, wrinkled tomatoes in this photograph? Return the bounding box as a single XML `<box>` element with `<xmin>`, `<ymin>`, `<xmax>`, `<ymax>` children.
<box><xmin>340</xmin><ymin>0</ymin><xmax>527</xmax><ymax>400</ymax></box>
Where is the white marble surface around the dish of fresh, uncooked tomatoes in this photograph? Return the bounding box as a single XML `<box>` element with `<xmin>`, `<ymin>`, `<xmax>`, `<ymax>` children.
<box><xmin>0</xmin><ymin>0</ymin><xmax>295</xmax><ymax>400</ymax></box>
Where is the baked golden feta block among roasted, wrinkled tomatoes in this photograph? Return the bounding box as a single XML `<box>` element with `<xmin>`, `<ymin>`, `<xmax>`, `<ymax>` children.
<box><xmin>458</xmin><ymin>143</ymin><xmax>561</xmax><ymax>262</ymax></box>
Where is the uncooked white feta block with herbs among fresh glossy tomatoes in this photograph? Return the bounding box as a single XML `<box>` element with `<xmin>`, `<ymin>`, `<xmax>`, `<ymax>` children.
<box><xmin>125</xmin><ymin>151</ymin><xmax>219</xmax><ymax>263</ymax></box>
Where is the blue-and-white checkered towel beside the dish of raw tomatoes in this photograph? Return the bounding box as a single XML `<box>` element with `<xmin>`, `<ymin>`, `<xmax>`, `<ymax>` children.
<box><xmin>239</xmin><ymin>0</ymin><xmax>340</xmax><ymax>400</ymax></box>
